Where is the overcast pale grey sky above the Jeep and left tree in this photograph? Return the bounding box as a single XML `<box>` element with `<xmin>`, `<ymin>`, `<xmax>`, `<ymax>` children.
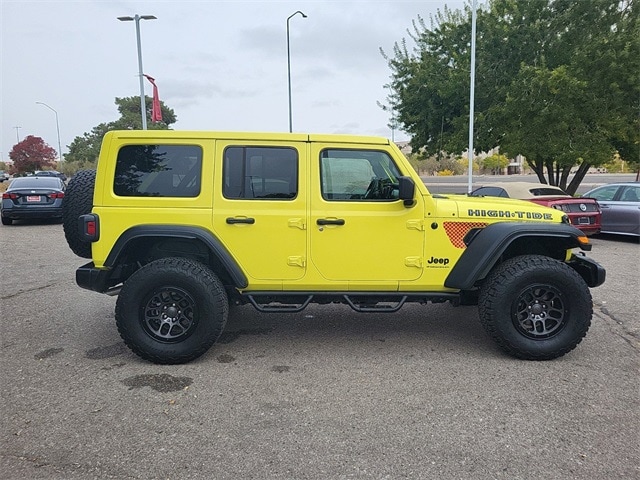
<box><xmin>0</xmin><ymin>0</ymin><xmax>464</xmax><ymax>160</ymax></box>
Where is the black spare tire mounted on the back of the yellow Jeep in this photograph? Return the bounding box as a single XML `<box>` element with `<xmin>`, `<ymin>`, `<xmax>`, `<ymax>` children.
<box><xmin>62</xmin><ymin>170</ymin><xmax>96</xmax><ymax>258</ymax></box>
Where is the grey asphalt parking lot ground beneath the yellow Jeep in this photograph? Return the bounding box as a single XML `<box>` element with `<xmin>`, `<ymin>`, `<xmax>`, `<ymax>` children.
<box><xmin>0</xmin><ymin>222</ymin><xmax>640</xmax><ymax>480</ymax></box>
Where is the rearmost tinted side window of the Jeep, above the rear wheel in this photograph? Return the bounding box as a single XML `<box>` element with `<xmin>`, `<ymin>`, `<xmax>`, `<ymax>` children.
<box><xmin>113</xmin><ymin>145</ymin><xmax>202</xmax><ymax>197</ymax></box>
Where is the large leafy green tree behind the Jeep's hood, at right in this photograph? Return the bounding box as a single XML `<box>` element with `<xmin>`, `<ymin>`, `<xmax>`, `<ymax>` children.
<box><xmin>386</xmin><ymin>0</ymin><xmax>640</xmax><ymax>193</ymax></box>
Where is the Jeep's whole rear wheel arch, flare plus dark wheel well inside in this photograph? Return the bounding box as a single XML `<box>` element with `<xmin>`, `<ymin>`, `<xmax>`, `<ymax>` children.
<box><xmin>104</xmin><ymin>225</ymin><xmax>248</xmax><ymax>288</ymax></box>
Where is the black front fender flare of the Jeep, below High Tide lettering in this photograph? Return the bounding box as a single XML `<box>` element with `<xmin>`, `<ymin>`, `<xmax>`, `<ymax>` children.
<box><xmin>444</xmin><ymin>222</ymin><xmax>591</xmax><ymax>290</ymax></box>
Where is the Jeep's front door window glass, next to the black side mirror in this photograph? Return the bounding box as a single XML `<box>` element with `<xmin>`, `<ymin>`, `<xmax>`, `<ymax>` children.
<box><xmin>320</xmin><ymin>149</ymin><xmax>400</xmax><ymax>201</ymax></box>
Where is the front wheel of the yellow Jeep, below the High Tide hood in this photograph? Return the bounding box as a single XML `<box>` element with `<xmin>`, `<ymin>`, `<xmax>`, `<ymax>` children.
<box><xmin>478</xmin><ymin>255</ymin><xmax>593</xmax><ymax>360</ymax></box>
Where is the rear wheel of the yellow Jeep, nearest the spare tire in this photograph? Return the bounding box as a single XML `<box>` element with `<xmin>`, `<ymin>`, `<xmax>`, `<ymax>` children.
<box><xmin>116</xmin><ymin>258</ymin><xmax>229</xmax><ymax>364</ymax></box>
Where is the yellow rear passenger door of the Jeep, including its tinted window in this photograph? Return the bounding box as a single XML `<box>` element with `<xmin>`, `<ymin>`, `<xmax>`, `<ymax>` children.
<box><xmin>213</xmin><ymin>140</ymin><xmax>307</xmax><ymax>289</ymax></box>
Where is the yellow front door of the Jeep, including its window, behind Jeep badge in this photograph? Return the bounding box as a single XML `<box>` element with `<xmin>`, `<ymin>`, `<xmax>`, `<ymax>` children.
<box><xmin>309</xmin><ymin>143</ymin><xmax>424</xmax><ymax>289</ymax></box>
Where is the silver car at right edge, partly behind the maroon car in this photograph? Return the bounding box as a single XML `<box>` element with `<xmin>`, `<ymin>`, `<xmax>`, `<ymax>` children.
<box><xmin>582</xmin><ymin>182</ymin><xmax>640</xmax><ymax>237</ymax></box>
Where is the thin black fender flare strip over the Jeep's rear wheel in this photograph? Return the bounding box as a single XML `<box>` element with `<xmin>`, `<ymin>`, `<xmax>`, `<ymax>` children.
<box><xmin>104</xmin><ymin>225</ymin><xmax>249</xmax><ymax>289</ymax></box>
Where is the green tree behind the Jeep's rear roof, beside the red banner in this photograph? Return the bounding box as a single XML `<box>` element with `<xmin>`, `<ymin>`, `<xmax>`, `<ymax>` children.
<box><xmin>64</xmin><ymin>96</ymin><xmax>177</xmax><ymax>164</ymax></box>
